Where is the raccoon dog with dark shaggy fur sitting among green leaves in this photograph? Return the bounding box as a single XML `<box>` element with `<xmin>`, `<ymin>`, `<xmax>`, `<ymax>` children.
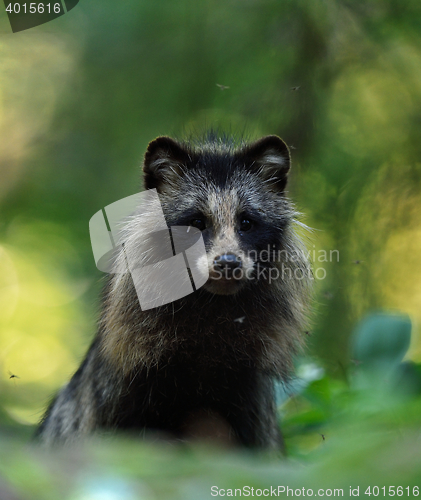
<box><xmin>38</xmin><ymin>134</ymin><xmax>311</xmax><ymax>448</ymax></box>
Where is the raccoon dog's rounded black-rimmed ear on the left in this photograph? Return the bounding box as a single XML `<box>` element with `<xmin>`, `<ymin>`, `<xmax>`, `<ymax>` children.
<box><xmin>143</xmin><ymin>137</ymin><xmax>189</xmax><ymax>192</ymax></box>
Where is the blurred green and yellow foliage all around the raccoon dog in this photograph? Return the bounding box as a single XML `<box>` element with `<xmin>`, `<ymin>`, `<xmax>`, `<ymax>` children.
<box><xmin>0</xmin><ymin>0</ymin><xmax>421</xmax><ymax>499</ymax></box>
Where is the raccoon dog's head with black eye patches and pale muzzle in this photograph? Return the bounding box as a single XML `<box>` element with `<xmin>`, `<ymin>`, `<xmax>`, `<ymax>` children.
<box><xmin>143</xmin><ymin>135</ymin><xmax>294</xmax><ymax>295</ymax></box>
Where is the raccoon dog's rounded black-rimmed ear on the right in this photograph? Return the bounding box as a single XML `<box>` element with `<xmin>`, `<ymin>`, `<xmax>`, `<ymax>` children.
<box><xmin>243</xmin><ymin>135</ymin><xmax>291</xmax><ymax>192</ymax></box>
